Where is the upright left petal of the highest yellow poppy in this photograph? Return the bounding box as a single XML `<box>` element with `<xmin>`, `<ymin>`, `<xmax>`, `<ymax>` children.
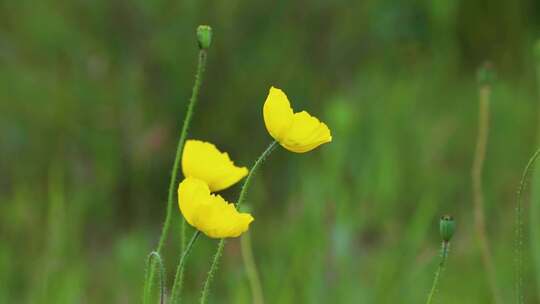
<box><xmin>263</xmin><ymin>87</ymin><xmax>293</xmax><ymax>141</ymax></box>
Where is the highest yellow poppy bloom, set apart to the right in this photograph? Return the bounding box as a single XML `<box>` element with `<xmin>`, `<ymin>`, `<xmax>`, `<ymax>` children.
<box><xmin>263</xmin><ymin>87</ymin><xmax>332</xmax><ymax>153</ymax></box>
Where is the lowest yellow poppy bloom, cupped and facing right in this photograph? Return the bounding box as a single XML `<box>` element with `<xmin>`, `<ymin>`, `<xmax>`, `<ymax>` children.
<box><xmin>178</xmin><ymin>177</ymin><xmax>253</xmax><ymax>238</ymax></box>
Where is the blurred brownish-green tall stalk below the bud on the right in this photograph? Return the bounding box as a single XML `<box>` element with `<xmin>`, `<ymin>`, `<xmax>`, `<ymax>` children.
<box><xmin>471</xmin><ymin>71</ymin><xmax>502</xmax><ymax>304</ymax></box>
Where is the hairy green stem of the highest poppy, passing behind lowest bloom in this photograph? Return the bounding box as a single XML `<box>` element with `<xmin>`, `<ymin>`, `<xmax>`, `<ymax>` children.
<box><xmin>200</xmin><ymin>141</ymin><xmax>278</xmax><ymax>304</ymax></box>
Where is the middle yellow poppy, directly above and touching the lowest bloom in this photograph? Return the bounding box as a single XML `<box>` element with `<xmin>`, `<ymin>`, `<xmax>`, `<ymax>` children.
<box><xmin>182</xmin><ymin>140</ymin><xmax>248</xmax><ymax>192</ymax></box>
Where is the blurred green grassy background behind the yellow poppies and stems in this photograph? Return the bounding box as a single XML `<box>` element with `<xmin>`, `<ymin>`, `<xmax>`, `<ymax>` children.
<box><xmin>0</xmin><ymin>0</ymin><xmax>540</xmax><ymax>303</ymax></box>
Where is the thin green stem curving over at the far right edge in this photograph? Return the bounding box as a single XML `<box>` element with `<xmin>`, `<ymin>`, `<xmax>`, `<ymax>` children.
<box><xmin>514</xmin><ymin>149</ymin><xmax>540</xmax><ymax>304</ymax></box>
